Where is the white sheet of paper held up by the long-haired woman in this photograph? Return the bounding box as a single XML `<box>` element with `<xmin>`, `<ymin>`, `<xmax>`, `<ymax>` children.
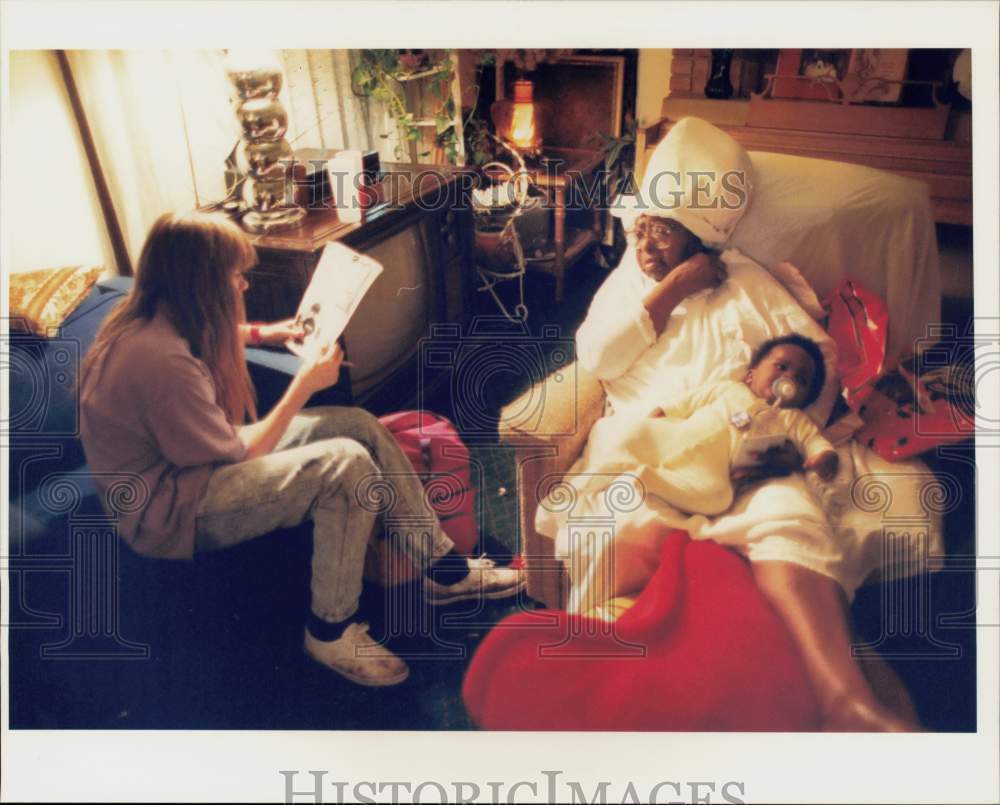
<box><xmin>288</xmin><ymin>242</ymin><xmax>382</xmax><ymax>358</ymax></box>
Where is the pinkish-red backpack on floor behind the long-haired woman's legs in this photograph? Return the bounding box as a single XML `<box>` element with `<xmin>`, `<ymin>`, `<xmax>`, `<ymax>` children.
<box><xmin>379</xmin><ymin>411</ymin><xmax>479</xmax><ymax>555</ymax></box>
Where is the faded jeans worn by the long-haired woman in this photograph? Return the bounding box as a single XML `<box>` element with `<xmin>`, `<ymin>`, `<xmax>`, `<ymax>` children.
<box><xmin>195</xmin><ymin>407</ymin><xmax>453</xmax><ymax>622</ymax></box>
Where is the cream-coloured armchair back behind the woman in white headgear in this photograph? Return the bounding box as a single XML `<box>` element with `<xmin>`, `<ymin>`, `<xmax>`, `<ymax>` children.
<box><xmin>726</xmin><ymin>152</ymin><xmax>941</xmax><ymax>366</ymax></box>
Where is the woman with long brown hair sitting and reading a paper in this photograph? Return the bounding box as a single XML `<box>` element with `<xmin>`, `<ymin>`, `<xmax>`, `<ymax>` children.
<box><xmin>80</xmin><ymin>213</ymin><xmax>523</xmax><ymax>685</ymax></box>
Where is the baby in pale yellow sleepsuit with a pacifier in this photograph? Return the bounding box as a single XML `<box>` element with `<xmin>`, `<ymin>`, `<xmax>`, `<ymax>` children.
<box><xmin>585</xmin><ymin>334</ymin><xmax>838</xmax><ymax>515</ymax></box>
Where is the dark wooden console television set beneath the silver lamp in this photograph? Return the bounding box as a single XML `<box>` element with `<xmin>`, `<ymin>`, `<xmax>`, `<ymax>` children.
<box><xmin>246</xmin><ymin>163</ymin><xmax>474</xmax><ymax>412</ymax></box>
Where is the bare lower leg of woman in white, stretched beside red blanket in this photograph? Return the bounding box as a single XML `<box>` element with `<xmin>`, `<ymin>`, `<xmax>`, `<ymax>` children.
<box><xmin>752</xmin><ymin>561</ymin><xmax>921</xmax><ymax>732</ymax></box>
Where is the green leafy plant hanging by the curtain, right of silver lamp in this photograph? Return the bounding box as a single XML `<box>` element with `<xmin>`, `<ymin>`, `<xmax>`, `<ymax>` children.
<box><xmin>351</xmin><ymin>50</ymin><xmax>458</xmax><ymax>165</ymax></box>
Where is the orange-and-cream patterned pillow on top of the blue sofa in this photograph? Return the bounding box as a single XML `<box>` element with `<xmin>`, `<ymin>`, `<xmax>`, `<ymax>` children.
<box><xmin>10</xmin><ymin>266</ymin><xmax>104</xmax><ymax>338</ymax></box>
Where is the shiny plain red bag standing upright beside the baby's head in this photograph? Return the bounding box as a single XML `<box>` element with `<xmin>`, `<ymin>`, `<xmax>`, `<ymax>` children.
<box><xmin>823</xmin><ymin>277</ymin><xmax>889</xmax><ymax>411</ymax></box>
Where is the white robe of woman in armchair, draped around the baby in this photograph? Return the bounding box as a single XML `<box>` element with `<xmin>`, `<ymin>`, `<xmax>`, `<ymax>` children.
<box><xmin>536</xmin><ymin>248</ymin><xmax>943</xmax><ymax>611</ymax></box>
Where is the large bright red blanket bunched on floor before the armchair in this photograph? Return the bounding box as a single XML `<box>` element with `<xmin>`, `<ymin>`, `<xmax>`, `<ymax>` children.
<box><xmin>462</xmin><ymin>531</ymin><xmax>818</xmax><ymax>731</ymax></box>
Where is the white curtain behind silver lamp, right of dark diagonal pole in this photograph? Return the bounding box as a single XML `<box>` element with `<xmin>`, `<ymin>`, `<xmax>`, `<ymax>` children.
<box><xmin>60</xmin><ymin>50</ymin><xmax>397</xmax><ymax>265</ymax></box>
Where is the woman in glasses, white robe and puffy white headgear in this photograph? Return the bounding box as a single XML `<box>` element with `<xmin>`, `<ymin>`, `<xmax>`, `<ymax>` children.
<box><xmin>537</xmin><ymin>118</ymin><xmax>919</xmax><ymax>730</ymax></box>
